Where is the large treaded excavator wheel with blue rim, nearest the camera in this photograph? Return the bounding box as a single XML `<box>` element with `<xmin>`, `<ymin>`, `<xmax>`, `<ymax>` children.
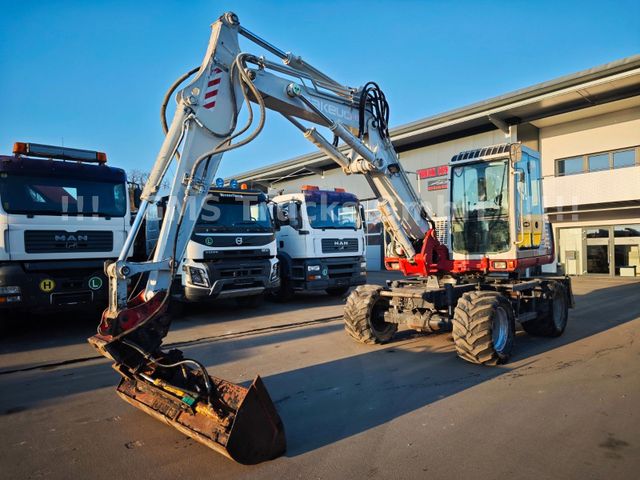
<box><xmin>453</xmin><ymin>292</ymin><xmax>515</xmax><ymax>365</ymax></box>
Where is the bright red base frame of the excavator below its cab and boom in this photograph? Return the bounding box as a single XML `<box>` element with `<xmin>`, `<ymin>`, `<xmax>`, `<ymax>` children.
<box><xmin>384</xmin><ymin>230</ymin><xmax>554</xmax><ymax>276</ymax></box>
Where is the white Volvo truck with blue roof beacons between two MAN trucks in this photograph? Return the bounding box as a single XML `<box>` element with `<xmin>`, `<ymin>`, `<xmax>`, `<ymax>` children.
<box><xmin>180</xmin><ymin>178</ymin><xmax>280</xmax><ymax>307</ymax></box>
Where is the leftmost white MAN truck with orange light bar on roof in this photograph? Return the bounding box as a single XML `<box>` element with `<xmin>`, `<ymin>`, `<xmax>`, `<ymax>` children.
<box><xmin>0</xmin><ymin>142</ymin><xmax>130</xmax><ymax>318</ymax></box>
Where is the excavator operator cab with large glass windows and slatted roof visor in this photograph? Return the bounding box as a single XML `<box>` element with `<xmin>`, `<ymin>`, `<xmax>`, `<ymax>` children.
<box><xmin>448</xmin><ymin>143</ymin><xmax>553</xmax><ymax>272</ymax></box>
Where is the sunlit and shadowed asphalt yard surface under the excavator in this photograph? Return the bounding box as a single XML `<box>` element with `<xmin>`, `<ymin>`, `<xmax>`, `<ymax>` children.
<box><xmin>0</xmin><ymin>274</ymin><xmax>640</xmax><ymax>480</ymax></box>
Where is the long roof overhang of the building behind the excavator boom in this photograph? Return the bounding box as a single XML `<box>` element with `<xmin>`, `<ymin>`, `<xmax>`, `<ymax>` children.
<box><xmin>235</xmin><ymin>55</ymin><xmax>640</xmax><ymax>184</ymax></box>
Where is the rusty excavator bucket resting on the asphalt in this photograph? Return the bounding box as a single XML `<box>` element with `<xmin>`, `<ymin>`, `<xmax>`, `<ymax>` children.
<box><xmin>88</xmin><ymin>335</ymin><xmax>286</xmax><ymax>465</ymax></box>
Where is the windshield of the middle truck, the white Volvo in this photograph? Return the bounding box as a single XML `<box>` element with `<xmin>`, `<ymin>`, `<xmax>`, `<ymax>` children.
<box><xmin>196</xmin><ymin>194</ymin><xmax>273</xmax><ymax>232</ymax></box>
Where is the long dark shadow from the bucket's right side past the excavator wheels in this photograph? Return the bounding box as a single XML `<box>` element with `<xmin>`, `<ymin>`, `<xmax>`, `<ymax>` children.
<box><xmin>264</xmin><ymin>283</ymin><xmax>640</xmax><ymax>457</ymax></box>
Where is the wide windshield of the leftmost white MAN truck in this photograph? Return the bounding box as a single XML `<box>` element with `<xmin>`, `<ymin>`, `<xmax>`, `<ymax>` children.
<box><xmin>0</xmin><ymin>172</ymin><xmax>127</xmax><ymax>217</ymax></box>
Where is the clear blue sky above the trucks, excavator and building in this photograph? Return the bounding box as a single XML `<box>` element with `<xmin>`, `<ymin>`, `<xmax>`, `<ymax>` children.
<box><xmin>0</xmin><ymin>0</ymin><xmax>640</xmax><ymax>176</ymax></box>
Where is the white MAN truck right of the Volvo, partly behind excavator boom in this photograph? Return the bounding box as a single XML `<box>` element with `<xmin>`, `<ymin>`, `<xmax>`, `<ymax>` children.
<box><xmin>272</xmin><ymin>185</ymin><xmax>366</xmax><ymax>301</ymax></box>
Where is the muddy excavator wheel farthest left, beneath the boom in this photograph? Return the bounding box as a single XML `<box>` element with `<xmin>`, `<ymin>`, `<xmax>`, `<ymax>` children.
<box><xmin>344</xmin><ymin>285</ymin><xmax>398</xmax><ymax>344</ymax></box>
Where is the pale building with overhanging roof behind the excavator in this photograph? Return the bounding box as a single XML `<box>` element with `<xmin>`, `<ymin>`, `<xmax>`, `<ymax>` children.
<box><xmin>236</xmin><ymin>55</ymin><xmax>640</xmax><ymax>277</ymax></box>
